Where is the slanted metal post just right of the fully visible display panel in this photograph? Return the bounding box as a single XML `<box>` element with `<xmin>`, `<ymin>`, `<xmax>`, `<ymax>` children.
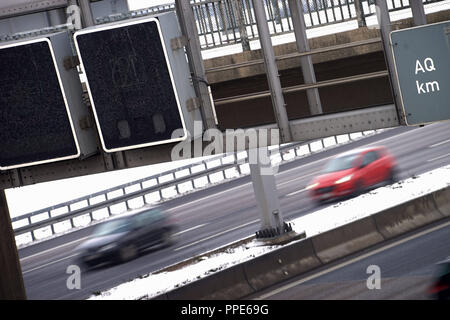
<box><xmin>175</xmin><ymin>0</ymin><xmax>216</xmax><ymax>130</ymax></box>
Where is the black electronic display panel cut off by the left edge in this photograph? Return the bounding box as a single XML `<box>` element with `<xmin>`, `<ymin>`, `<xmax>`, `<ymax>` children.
<box><xmin>0</xmin><ymin>39</ymin><xmax>79</xmax><ymax>170</ymax></box>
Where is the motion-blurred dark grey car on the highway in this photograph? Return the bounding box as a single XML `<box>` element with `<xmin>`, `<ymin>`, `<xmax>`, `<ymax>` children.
<box><xmin>76</xmin><ymin>207</ymin><xmax>176</xmax><ymax>268</ymax></box>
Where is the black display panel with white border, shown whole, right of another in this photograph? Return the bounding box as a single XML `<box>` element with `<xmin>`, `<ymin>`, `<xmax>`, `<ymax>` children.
<box><xmin>75</xmin><ymin>18</ymin><xmax>185</xmax><ymax>152</ymax></box>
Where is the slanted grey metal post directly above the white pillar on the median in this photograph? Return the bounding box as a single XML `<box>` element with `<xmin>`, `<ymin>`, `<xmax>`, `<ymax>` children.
<box><xmin>252</xmin><ymin>0</ymin><xmax>292</xmax><ymax>143</ymax></box>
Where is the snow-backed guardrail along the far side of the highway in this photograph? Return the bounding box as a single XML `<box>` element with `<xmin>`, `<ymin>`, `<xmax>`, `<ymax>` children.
<box><xmin>11</xmin><ymin>130</ymin><xmax>382</xmax><ymax>246</ymax></box>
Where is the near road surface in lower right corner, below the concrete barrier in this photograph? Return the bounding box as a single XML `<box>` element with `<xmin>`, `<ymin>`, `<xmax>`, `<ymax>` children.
<box><xmin>250</xmin><ymin>219</ymin><xmax>450</xmax><ymax>300</ymax></box>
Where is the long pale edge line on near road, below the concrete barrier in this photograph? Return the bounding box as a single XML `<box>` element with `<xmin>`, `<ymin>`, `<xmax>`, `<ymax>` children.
<box><xmin>254</xmin><ymin>221</ymin><xmax>450</xmax><ymax>300</ymax></box>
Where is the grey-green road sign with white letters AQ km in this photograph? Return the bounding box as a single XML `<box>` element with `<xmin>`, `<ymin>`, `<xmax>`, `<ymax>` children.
<box><xmin>390</xmin><ymin>21</ymin><xmax>450</xmax><ymax>125</ymax></box>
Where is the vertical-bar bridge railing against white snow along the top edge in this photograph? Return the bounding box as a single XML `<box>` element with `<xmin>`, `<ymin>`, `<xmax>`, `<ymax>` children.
<box><xmin>108</xmin><ymin>0</ymin><xmax>444</xmax><ymax>50</ymax></box>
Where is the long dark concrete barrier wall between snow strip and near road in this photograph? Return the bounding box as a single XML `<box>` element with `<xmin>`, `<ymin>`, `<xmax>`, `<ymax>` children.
<box><xmin>153</xmin><ymin>186</ymin><xmax>450</xmax><ymax>300</ymax></box>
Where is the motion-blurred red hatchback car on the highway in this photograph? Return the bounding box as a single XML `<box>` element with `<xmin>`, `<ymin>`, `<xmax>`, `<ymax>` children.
<box><xmin>306</xmin><ymin>146</ymin><xmax>396</xmax><ymax>203</ymax></box>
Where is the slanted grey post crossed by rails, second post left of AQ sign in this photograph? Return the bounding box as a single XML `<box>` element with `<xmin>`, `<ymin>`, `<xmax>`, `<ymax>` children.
<box><xmin>289</xmin><ymin>0</ymin><xmax>323</xmax><ymax>115</ymax></box>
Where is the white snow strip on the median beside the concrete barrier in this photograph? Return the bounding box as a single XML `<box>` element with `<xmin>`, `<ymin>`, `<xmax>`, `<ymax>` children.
<box><xmin>89</xmin><ymin>165</ymin><xmax>450</xmax><ymax>300</ymax></box>
